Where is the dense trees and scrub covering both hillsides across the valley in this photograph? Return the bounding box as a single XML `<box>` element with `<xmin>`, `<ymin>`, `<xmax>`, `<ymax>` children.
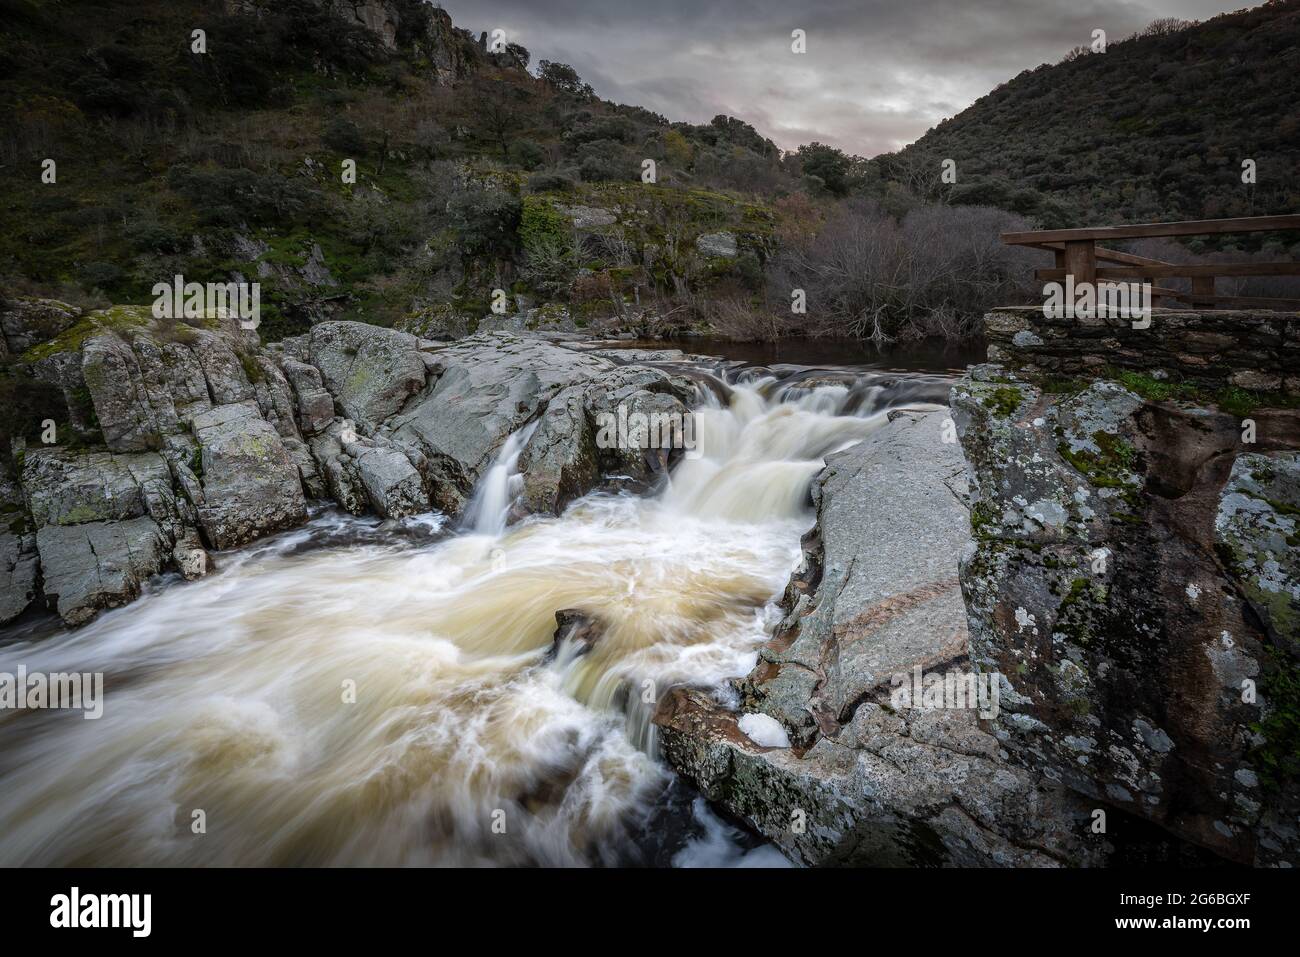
<box><xmin>0</xmin><ymin>0</ymin><xmax>1297</xmax><ymax>339</ymax></box>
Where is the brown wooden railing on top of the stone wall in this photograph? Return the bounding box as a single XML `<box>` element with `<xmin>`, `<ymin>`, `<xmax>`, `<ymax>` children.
<box><xmin>1002</xmin><ymin>216</ymin><xmax>1300</xmax><ymax>309</ymax></box>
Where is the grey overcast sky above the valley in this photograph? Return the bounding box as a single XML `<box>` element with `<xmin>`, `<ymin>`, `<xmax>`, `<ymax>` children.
<box><xmin>441</xmin><ymin>0</ymin><xmax>1253</xmax><ymax>156</ymax></box>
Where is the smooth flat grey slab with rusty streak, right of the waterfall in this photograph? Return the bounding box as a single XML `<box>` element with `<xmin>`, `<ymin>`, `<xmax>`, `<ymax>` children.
<box><xmin>742</xmin><ymin>412</ymin><xmax>970</xmax><ymax>740</ymax></box>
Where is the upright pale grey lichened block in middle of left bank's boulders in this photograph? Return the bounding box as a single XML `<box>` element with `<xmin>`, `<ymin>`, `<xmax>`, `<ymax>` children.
<box><xmin>194</xmin><ymin>404</ymin><xmax>307</xmax><ymax>549</ymax></box>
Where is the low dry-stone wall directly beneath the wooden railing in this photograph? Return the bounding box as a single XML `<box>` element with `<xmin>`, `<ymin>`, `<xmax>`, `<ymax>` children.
<box><xmin>984</xmin><ymin>307</ymin><xmax>1300</xmax><ymax>395</ymax></box>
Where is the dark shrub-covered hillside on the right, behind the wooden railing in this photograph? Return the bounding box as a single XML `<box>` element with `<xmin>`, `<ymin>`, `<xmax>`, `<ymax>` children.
<box><xmin>881</xmin><ymin>0</ymin><xmax>1300</xmax><ymax>242</ymax></box>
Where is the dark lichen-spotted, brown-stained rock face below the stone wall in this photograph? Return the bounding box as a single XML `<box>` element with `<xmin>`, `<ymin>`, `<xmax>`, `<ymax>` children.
<box><xmin>952</xmin><ymin>365</ymin><xmax>1300</xmax><ymax>863</ymax></box>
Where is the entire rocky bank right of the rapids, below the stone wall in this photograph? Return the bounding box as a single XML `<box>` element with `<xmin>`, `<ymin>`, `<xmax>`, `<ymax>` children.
<box><xmin>658</xmin><ymin>315</ymin><xmax>1300</xmax><ymax>866</ymax></box>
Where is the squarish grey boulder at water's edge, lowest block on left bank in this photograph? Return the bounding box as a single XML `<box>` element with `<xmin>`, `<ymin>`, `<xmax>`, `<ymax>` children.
<box><xmin>36</xmin><ymin>518</ymin><xmax>170</xmax><ymax>625</ymax></box>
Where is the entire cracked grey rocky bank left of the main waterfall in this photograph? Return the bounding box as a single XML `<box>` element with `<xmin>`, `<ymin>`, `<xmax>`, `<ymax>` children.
<box><xmin>0</xmin><ymin>299</ymin><xmax>693</xmax><ymax>624</ymax></box>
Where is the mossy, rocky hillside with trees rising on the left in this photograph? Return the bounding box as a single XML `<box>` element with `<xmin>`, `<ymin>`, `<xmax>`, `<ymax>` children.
<box><xmin>0</xmin><ymin>0</ymin><xmax>794</xmax><ymax>339</ymax></box>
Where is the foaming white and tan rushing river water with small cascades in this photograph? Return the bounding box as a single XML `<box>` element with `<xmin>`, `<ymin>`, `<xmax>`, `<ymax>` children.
<box><xmin>0</xmin><ymin>364</ymin><xmax>946</xmax><ymax>865</ymax></box>
